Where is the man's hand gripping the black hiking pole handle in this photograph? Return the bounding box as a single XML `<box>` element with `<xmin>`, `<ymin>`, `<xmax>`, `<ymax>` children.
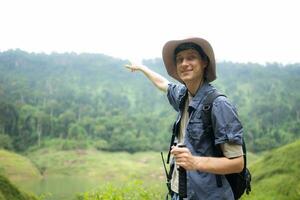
<box><xmin>171</xmin><ymin>146</ymin><xmax>198</xmax><ymax>170</ymax></box>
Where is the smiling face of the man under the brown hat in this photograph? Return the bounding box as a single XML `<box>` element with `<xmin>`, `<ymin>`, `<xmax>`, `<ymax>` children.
<box><xmin>176</xmin><ymin>49</ymin><xmax>206</xmax><ymax>83</ymax></box>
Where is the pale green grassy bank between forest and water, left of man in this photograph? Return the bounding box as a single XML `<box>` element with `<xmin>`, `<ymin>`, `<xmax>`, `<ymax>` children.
<box><xmin>28</xmin><ymin>148</ymin><xmax>164</xmax><ymax>184</ymax></box>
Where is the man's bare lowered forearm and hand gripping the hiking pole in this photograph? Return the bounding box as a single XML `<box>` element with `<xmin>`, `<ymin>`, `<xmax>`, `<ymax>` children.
<box><xmin>171</xmin><ymin>147</ymin><xmax>244</xmax><ymax>174</ymax></box>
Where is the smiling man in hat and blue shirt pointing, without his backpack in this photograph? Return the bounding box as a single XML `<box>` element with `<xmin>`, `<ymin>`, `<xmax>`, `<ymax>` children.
<box><xmin>127</xmin><ymin>38</ymin><xmax>244</xmax><ymax>200</ymax></box>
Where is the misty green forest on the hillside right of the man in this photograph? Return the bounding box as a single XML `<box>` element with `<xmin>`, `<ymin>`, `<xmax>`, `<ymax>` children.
<box><xmin>216</xmin><ymin>62</ymin><xmax>300</xmax><ymax>152</ymax></box>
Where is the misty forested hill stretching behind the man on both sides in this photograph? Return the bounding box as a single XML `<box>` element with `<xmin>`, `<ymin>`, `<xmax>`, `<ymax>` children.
<box><xmin>0</xmin><ymin>50</ymin><xmax>300</xmax><ymax>152</ymax></box>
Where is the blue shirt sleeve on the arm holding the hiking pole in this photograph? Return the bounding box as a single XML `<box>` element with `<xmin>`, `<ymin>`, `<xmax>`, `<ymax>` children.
<box><xmin>212</xmin><ymin>97</ymin><xmax>243</xmax><ymax>145</ymax></box>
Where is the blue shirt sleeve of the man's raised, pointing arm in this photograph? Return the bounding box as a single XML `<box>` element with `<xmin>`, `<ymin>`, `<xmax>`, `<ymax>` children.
<box><xmin>167</xmin><ymin>83</ymin><xmax>186</xmax><ymax>111</ymax></box>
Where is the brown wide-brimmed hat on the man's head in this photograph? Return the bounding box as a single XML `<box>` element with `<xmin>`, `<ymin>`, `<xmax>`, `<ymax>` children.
<box><xmin>162</xmin><ymin>38</ymin><xmax>217</xmax><ymax>82</ymax></box>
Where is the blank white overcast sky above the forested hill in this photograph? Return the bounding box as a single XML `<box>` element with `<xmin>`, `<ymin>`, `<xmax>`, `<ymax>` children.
<box><xmin>0</xmin><ymin>0</ymin><xmax>300</xmax><ymax>64</ymax></box>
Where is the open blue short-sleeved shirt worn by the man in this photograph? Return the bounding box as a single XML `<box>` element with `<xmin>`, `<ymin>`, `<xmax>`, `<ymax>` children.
<box><xmin>167</xmin><ymin>83</ymin><xmax>243</xmax><ymax>200</ymax></box>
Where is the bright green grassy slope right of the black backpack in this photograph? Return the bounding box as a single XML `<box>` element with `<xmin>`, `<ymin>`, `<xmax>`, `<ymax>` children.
<box><xmin>244</xmin><ymin>140</ymin><xmax>300</xmax><ymax>200</ymax></box>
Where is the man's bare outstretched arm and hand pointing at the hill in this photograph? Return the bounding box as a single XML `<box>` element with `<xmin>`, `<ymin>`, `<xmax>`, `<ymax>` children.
<box><xmin>125</xmin><ymin>65</ymin><xmax>169</xmax><ymax>92</ymax></box>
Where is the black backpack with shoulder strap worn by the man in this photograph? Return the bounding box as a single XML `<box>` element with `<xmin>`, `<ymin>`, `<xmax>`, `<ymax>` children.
<box><xmin>201</xmin><ymin>90</ymin><xmax>251</xmax><ymax>200</ymax></box>
